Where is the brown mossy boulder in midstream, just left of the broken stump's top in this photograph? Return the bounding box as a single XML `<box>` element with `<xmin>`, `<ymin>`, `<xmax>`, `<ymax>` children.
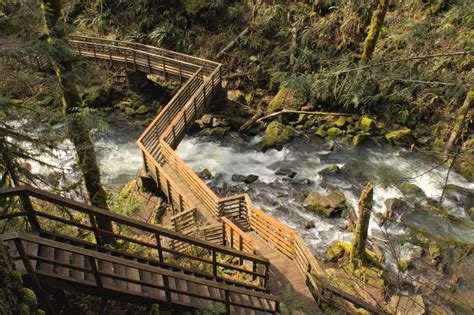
<box><xmin>304</xmin><ymin>191</ymin><xmax>347</xmax><ymax>218</ymax></box>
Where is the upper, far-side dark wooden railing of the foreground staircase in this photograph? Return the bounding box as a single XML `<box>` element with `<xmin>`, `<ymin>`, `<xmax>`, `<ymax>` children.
<box><xmin>0</xmin><ymin>186</ymin><xmax>270</xmax><ymax>287</ymax></box>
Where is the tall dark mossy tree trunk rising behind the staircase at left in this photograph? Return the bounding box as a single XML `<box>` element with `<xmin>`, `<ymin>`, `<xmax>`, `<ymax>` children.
<box><xmin>39</xmin><ymin>0</ymin><xmax>113</xmax><ymax>243</ymax></box>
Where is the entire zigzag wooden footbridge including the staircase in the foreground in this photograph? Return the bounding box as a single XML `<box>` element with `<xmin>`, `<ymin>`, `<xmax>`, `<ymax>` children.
<box><xmin>0</xmin><ymin>36</ymin><xmax>380</xmax><ymax>314</ymax></box>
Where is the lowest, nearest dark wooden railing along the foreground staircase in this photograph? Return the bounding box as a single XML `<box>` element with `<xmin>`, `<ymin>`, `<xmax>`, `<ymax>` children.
<box><xmin>0</xmin><ymin>233</ymin><xmax>280</xmax><ymax>314</ymax></box>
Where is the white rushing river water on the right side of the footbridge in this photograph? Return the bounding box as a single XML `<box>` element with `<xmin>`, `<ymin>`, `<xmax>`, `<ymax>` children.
<box><xmin>177</xmin><ymin>135</ymin><xmax>474</xmax><ymax>254</ymax></box>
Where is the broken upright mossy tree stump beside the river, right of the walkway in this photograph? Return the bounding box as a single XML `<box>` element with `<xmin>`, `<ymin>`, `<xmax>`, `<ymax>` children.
<box><xmin>350</xmin><ymin>182</ymin><xmax>374</xmax><ymax>268</ymax></box>
